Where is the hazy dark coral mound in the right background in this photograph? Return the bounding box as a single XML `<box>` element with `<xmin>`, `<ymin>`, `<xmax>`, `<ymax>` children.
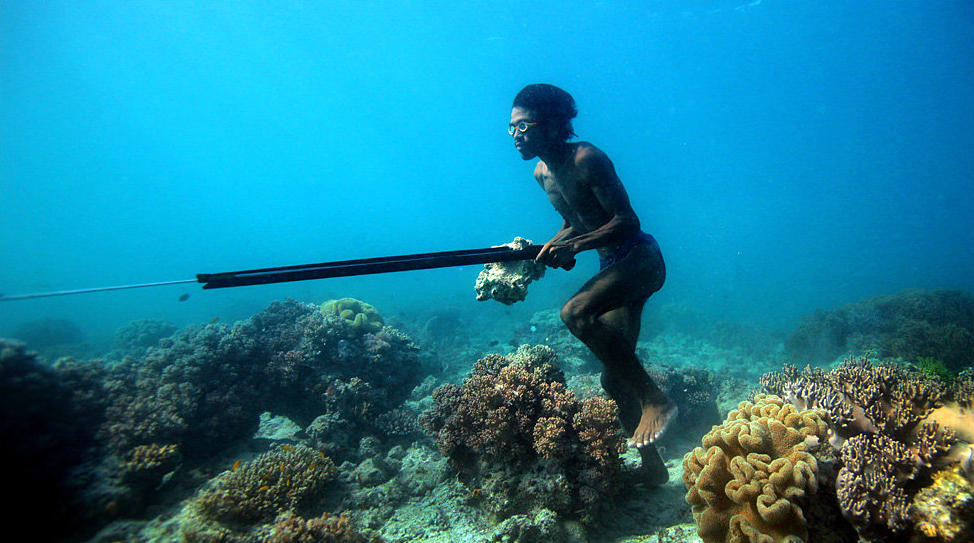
<box><xmin>785</xmin><ymin>289</ymin><xmax>974</xmax><ymax>374</ymax></box>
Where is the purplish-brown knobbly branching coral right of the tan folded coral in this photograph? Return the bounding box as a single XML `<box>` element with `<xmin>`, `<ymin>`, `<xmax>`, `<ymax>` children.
<box><xmin>761</xmin><ymin>358</ymin><xmax>974</xmax><ymax>541</ymax></box>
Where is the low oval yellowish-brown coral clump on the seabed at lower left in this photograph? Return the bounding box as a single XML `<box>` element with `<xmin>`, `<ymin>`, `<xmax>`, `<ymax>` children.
<box><xmin>181</xmin><ymin>445</ymin><xmax>338</xmax><ymax>541</ymax></box>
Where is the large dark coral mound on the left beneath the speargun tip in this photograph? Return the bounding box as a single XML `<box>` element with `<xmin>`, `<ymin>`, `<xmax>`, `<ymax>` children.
<box><xmin>0</xmin><ymin>300</ymin><xmax>419</xmax><ymax>540</ymax></box>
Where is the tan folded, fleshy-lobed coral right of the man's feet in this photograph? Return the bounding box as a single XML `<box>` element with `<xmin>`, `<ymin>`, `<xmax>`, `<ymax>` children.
<box><xmin>683</xmin><ymin>394</ymin><xmax>828</xmax><ymax>543</ymax></box>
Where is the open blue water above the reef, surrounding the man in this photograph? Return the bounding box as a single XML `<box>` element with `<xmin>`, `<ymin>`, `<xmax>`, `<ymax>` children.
<box><xmin>0</xmin><ymin>0</ymin><xmax>974</xmax><ymax>341</ymax></box>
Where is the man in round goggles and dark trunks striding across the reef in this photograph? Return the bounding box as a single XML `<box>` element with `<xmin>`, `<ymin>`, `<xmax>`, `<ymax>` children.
<box><xmin>508</xmin><ymin>84</ymin><xmax>677</xmax><ymax>484</ymax></box>
